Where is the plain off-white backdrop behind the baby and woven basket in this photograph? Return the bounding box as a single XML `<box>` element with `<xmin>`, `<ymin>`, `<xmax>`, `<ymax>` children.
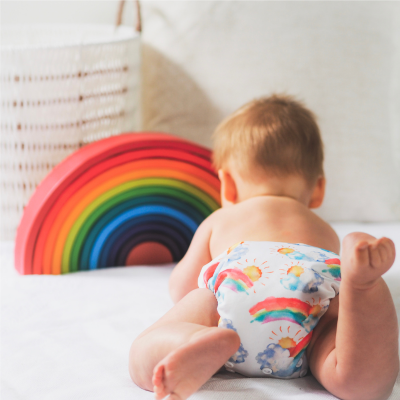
<box><xmin>0</xmin><ymin>0</ymin><xmax>400</xmax><ymax>221</ymax></box>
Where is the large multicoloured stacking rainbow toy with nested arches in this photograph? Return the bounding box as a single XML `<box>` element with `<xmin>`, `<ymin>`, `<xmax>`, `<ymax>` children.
<box><xmin>15</xmin><ymin>133</ymin><xmax>220</xmax><ymax>275</ymax></box>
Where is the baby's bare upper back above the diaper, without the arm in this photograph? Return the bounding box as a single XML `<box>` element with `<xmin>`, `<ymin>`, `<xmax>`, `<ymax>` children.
<box><xmin>210</xmin><ymin>196</ymin><xmax>340</xmax><ymax>258</ymax></box>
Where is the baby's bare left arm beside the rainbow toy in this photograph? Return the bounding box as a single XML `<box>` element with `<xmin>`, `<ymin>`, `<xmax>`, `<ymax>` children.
<box><xmin>169</xmin><ymin>211</ymin><xmax>218</xmax><ymax>303</ymax></box>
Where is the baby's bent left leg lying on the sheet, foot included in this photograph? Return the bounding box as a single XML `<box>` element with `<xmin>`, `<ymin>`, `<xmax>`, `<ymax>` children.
<box><xmin>129</xmin><ymin>289</ymin><xmax>240</xmax><ymax>399</ymax></box>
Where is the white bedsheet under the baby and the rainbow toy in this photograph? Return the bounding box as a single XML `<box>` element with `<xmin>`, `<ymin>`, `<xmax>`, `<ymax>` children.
<box><xmin>0</xmin><ymin>223</ymin><xmax>400</xmax><ymax>400</ymax></box>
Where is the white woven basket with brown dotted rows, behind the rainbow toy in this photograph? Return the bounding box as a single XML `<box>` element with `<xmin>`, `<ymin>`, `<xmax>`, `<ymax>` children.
<box><xmin>0</xmin><ymin>25</ymin><xmax>140</xmax><ymax>239</ymax></box>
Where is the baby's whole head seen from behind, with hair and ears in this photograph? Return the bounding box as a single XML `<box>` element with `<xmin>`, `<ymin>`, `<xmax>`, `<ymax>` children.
<box><xmin>213</xmin><ymin>95</ymin><xmax>325</xmax><ymax>208</ymax></box>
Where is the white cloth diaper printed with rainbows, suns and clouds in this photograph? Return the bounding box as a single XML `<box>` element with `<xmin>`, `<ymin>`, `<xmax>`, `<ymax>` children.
<box><xmin>198</xmin><ymin>242</ymin><xmax>340</xmax><ymax>378</ymax></box>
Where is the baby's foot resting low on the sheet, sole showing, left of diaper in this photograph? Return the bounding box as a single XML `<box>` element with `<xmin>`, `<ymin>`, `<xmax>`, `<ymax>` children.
<box><xmin>153</xmin><ymin>328</ymin><xmax>240</xmax><ymax>400</ymax></box>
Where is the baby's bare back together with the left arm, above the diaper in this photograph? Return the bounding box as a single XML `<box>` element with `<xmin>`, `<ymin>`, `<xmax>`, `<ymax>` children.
<box><xmin>170</xmin><ymin>196</ymin><xmax>340</xmax><ymax>302</ymax></box>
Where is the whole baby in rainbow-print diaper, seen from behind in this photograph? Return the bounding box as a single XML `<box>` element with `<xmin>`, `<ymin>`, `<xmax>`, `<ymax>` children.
<box><xmin>129</xmin><ymin>95</ymin><xmax>399</xmax><ymax>400</ymax></box>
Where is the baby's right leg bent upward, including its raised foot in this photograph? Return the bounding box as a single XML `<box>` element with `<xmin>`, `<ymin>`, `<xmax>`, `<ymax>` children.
<box><xmin>308</xmin><ymin>233</ymin><xmax>399</xmax><ymax>400</ymax></box>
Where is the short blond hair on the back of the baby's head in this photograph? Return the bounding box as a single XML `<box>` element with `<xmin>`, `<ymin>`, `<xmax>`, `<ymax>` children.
<box><xmin>213</xmin><ymin>95</ymin><xmax>324</xmax><ymax>185</ymax></box>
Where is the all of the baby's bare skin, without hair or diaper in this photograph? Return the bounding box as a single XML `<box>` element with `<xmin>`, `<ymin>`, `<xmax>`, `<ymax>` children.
<box><xmin>129</xmin><ymin>170</ymin><xmax>399</xmax><ymax>400</ymax></box>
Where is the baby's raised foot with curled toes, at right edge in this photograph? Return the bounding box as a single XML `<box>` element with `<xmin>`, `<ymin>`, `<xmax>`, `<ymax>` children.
<box><xmin>342</xmin><ymin>232</ymin><xmax>396</xmax><ymax>289</ymax></box>
